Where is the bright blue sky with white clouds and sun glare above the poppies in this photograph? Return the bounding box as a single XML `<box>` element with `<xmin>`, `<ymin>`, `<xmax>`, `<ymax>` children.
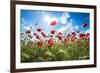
<box><xmin>20</xmin><ymin>10</ymin><xmax>90</xmax><ymax>34</ymax></box>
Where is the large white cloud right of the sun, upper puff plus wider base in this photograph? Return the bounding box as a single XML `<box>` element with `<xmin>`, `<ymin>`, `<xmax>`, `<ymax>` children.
<box><xmin>57</xmin><ymin>12</ymin><xmax>79</xmax><ymax>34</ymax></box>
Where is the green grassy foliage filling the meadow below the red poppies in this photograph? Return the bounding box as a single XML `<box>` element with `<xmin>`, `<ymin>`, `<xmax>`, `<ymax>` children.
<box><xmin>21</xmin><ymin>39</ymin><xmax>89</xmax><ymax>63</ymax></box>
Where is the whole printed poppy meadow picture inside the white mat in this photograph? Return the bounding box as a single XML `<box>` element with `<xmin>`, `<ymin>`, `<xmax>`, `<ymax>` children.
<box><xmin>20</xmin><ymin>10</ymin><xmax>90</xmax><ymax>63</ymax></box>
